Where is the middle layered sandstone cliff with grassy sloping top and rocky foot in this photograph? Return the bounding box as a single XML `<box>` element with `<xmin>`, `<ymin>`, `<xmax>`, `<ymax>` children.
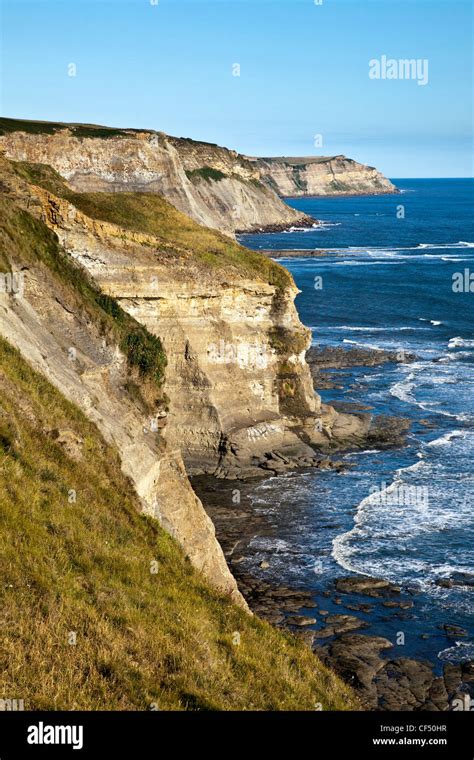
<box><xmin>9</xmin><ymin>160</ymin><xmax>369</xmax><ymax>477</ymax></box>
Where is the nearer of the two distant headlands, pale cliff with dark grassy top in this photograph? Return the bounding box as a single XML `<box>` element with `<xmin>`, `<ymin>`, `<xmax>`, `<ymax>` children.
<box><xmin>0</xmin><ymin>120</ymin><xmax>314</xmax><ymax>235</ymax></box>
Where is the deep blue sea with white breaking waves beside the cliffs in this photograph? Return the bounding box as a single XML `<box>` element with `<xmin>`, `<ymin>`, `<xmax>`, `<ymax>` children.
<box><xmin>241</xmin><ymin>179</ymin><xmax>474</xmax><ymax>669</ymax></box>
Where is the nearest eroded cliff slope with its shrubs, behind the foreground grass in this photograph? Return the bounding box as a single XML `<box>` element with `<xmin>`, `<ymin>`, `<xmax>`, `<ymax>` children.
<box><xmin>0</xmin><ymin>161</ymin><xmax>246</xmax><ymax>607</ymax></box>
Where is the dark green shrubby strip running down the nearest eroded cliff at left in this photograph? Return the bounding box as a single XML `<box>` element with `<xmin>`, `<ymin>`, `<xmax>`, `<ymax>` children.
<box><xmin>0</xmin><ymin>190</ymin><xmax>166</xmax><ymax>389</ymax></box>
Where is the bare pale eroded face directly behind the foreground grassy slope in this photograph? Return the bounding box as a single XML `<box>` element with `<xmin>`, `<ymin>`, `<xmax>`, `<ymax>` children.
<box><xmin>0</xmin><ymin>162</ymin><xmax>247</xmax><ymax>608</ymax></box>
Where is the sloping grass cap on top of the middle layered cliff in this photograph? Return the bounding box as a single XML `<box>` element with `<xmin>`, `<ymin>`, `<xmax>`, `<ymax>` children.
<box><xmin>12</xmin><ymin>162</ymin><xmax>293</xmax><ymax>290</ymax></box>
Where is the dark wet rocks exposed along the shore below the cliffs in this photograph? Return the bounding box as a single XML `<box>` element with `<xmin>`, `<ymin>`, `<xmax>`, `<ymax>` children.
<box><xmin>192</xmin><ymin>348</ymin><xmax>474</xmax><ymax>711</ymax></box>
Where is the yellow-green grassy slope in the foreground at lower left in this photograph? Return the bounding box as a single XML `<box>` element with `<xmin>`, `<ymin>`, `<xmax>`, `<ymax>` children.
<box><xmin>0</xmin><ymin>338</ymin><xmax>357</xmax><ymax>710</ymax></box>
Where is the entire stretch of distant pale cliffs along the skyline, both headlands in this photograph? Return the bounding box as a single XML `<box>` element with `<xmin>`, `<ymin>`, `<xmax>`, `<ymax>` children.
<box><xmin>0</xmin><ymin>119</ymin><xmax>396</xmax><ymax>235</ymax></box>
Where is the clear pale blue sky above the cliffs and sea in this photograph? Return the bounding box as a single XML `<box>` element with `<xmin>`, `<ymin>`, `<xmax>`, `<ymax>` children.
<box><xmin>0</xmin><ymin>0</ymin><xmax>473</xmax><ymax>177</ymax></box>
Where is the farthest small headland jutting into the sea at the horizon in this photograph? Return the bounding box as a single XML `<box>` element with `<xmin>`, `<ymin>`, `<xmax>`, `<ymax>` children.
<box><xmin>252</xmin><ymin>156</ymin><xmax>398</xmax><ymax>197</ymax></box>
